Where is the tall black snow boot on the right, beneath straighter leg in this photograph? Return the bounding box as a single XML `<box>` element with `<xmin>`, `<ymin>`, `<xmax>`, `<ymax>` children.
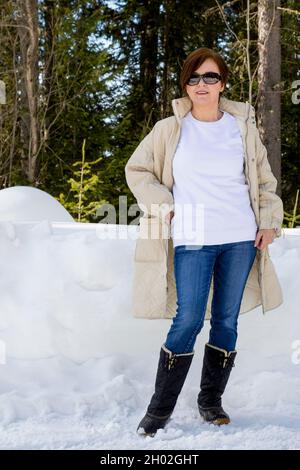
<box><xmin>197</xmin><ymin>343</ymin><xmax>237</xmax><ymax>426</ymax></box>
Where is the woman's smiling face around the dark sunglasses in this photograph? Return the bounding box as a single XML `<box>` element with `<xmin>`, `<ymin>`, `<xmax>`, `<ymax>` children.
<box><xmin>186</xmin><ymin>59</ymin><xmax>224</xmax><ymax>106</ymax></box>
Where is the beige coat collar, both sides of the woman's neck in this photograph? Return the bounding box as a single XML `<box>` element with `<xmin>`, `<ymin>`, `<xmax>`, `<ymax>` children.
<box><xmin>172</xmin><ymin>96</ymin><xmax>254</xmax><ymax>124</ymax></box>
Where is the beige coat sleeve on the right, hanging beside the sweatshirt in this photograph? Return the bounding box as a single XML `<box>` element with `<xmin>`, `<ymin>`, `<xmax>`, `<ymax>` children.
<box><xmin>256</xmin><ymin>128</ymin><xmax>284</xmax><ymax>237</ymax></box>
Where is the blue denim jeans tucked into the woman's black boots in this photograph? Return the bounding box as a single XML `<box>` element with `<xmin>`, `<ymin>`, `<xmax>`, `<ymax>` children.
<box><xmin>165</xmin><ymin>240</ymin><xmax>258</xmax><ymax>354</ymax></box>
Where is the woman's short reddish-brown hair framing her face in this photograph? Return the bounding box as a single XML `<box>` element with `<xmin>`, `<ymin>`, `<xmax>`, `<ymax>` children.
<box><xmin>180</xmin><ymin>47</ymin><xmax>229</xmax><ymax>99</ymax></box>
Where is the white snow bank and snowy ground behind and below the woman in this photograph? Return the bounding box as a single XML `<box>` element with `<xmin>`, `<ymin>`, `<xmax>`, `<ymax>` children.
<box><xmin>0</xmin><ymin>217</ymin><xmax>300</xmax><ymax>450</ymax></box>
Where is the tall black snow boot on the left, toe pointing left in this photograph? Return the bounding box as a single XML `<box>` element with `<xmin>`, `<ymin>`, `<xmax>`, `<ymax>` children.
<box><xmin>137</xmin><ymin>345</ymin><xmax>194</xmax><ymax>437</ymax></box>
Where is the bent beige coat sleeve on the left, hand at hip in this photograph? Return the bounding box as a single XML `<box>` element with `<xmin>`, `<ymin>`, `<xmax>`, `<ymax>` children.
<box><xmin>125</xmin><ymin>126</ymin><xmax>174</xmax><ymax>221</ymax></box>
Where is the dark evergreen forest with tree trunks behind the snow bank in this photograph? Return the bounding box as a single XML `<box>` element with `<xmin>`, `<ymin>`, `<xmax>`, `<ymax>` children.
<box><xmin>0</xmin><ymin>0</ymin><xmax>300</xmax><ymax>227</ymax></box>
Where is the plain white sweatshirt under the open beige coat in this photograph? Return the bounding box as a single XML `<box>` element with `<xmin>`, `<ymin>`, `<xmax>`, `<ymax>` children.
<box><xmin>171</xmin><ymin>111</ymin><xmax>257</xmax><ymax>247</ymax></box>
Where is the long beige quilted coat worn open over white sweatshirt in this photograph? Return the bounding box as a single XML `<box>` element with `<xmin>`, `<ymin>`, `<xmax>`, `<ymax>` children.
<box><xmin>125</xmin><ymin>96</ymin><xmax>283</xmax><ymax>319</ymax></box>
